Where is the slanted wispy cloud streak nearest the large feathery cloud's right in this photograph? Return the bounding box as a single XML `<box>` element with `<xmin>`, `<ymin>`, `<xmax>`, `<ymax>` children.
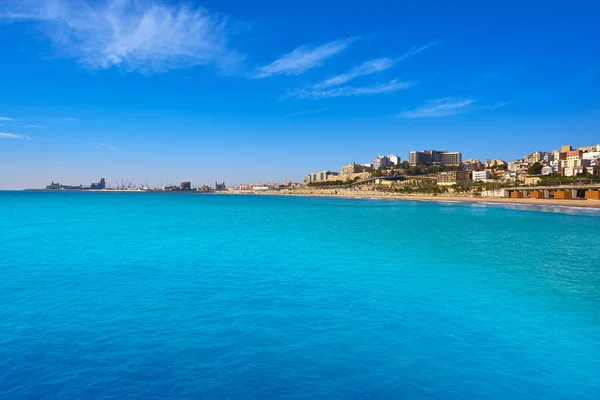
<box><xmin>249</xmin><ymin>37</ymin><xmax>357</xmax><ymax>79</ymax></box>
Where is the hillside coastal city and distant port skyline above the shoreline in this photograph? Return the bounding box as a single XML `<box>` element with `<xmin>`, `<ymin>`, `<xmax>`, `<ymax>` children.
<box><xmin>30</xmin><ymin>140</ymin><xmax>600</xmax><ymax>191</ymax></box>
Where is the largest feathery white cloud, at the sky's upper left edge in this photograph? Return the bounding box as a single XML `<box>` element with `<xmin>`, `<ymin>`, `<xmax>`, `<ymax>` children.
<box><xmin>0</xmin><ymin>0</ymin><xmax>240</xmax><ymax>73</ymax></box>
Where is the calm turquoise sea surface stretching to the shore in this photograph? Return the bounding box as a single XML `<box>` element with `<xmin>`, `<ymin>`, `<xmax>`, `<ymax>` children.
<box><xmin>0</xmin><ymin>192</ymin><xmax>600</xmax><ymax>400</ymax></box>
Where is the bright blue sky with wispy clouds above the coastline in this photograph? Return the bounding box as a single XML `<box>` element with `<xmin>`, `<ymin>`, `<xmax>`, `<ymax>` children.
<box><xmin>0</xmin><ymin>0</ymin><xmax>600</xmax><ymax>189</ymax></box>
